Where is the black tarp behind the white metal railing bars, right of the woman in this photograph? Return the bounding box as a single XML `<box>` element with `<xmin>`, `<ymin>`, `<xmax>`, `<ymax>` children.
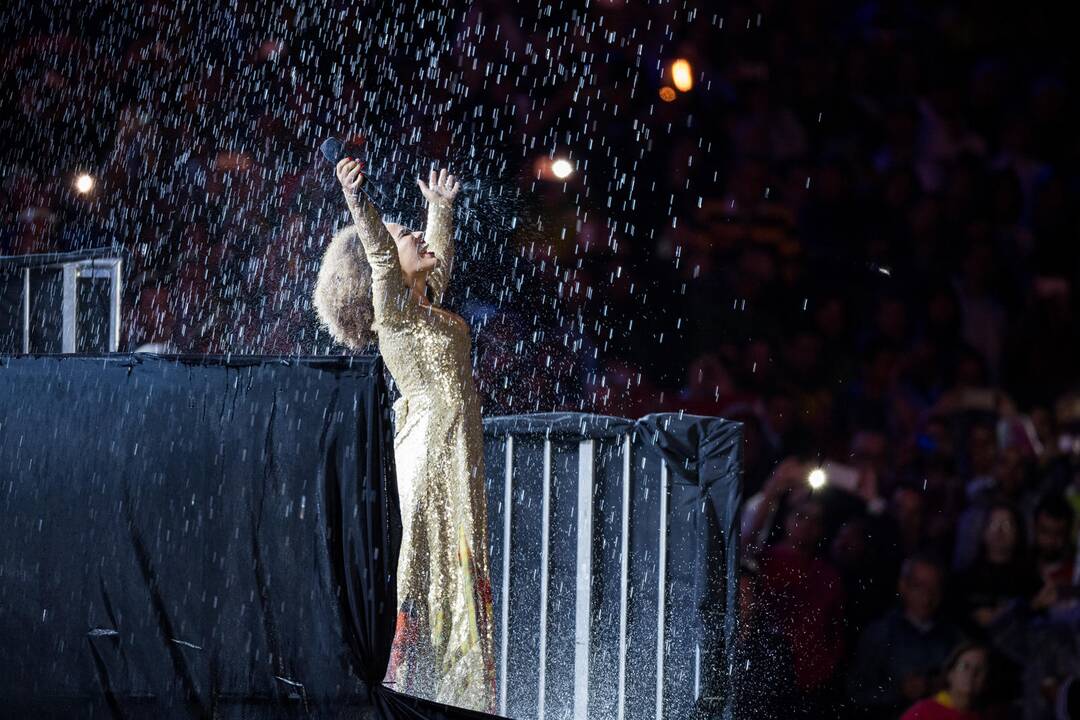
<box><xmin>484</xmin><ymin>413</ymin><xmax>742</xmax><ymax>720</ymax></box>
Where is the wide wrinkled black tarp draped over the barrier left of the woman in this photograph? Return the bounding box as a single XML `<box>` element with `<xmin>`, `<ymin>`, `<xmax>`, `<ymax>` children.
<box><xmin>0</xmin><ymin>355</ymin><xmax>498</xmax><ymax>720</ymax></box>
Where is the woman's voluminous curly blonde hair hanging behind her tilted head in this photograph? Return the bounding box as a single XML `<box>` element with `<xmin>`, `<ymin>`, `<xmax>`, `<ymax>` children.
<box><xmin>314</xmin><ymin>223</ymin><xmax>375</xmax><ymax>350</ymax></box>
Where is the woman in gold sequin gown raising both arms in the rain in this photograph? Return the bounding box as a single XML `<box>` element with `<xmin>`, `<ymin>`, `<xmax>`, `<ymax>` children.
<box><xmin>315</xmin><ymin>159</ymin><xmax>495</xmax><ymax>712</ymax></box>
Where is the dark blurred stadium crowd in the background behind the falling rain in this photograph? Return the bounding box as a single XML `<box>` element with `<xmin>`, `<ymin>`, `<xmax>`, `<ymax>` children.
<box><xmin>0</xmin><ymin>0</ymin><xmax>1080</xmax><ymax>720</ymax></box>
